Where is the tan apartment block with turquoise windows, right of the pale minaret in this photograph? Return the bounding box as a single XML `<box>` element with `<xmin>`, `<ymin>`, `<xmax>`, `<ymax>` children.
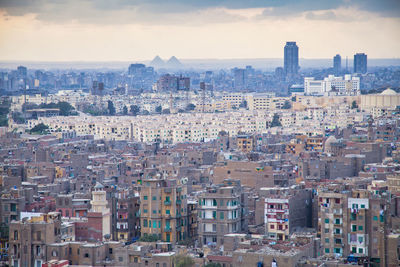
<box><xmin>140</xmin><ymin>178</ymin><xmax>188</xmax><ymax>243</ymax></box>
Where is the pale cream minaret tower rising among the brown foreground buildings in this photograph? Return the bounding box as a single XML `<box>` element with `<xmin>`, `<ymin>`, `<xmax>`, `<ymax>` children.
<box><xmin>90</xmin><ymin>182</ymin><xmax>111</xmax><ymax>242</ymax></box>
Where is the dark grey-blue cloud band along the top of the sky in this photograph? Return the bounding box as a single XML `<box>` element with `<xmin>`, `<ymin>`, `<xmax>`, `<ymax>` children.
<box><xmin>0</xmin><ymin>0</ymin><xmax>400</xmax><ymax>25</ymax></box>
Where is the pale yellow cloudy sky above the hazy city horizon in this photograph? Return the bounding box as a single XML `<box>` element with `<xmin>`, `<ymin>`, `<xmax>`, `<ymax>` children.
<box><xmin>0</xmin><ymin>0</ymin><xmax>400</xmax><ymax>61</ymax></box>
